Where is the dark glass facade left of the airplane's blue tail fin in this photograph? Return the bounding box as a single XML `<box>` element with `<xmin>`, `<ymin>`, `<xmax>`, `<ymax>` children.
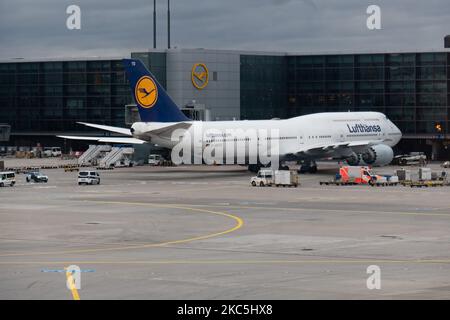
<box><xmin>0</xmin><ymin>60</ymin><xmax>131</xmax><ymax>133</ymax></box>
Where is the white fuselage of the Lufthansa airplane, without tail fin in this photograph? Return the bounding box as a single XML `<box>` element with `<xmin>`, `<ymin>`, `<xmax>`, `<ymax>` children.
<box><xmin>132</xmin><ymin>112</ymin><xmax>402</xmax><ymax>160</ymax></box>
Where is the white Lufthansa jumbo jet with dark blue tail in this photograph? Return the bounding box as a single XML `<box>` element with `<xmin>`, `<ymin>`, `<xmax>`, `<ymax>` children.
<box><xmin>59</xmin><ymin>59</ymin><xmax>402</xmax><ymax>172</ymax></box>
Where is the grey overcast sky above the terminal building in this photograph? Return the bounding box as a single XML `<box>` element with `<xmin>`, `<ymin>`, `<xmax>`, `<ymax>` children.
<box><xmin>0</xmin><ymin>0</ymin><xmax>450</xmax><ymax>59</ymax></box>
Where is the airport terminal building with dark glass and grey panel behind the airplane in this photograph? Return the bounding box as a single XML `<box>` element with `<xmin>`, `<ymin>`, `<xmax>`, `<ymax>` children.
<box><xmin>0</xmin><ymin>49</ymin><xmax>450</xmax><ymax>159</ymax></box>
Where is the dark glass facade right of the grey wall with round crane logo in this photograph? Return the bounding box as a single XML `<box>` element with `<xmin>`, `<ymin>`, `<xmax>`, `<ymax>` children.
<box><xmin>241</xmin><ymin>52</ymin><xmax>450</xmax><ymax>135</ymax></box>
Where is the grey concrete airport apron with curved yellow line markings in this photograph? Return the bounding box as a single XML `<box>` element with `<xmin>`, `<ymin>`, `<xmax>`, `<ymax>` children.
<box><xmin>0</xmin><ymin>163</ymin><xmax>450</xmax><ymax>299</ymax></box>
